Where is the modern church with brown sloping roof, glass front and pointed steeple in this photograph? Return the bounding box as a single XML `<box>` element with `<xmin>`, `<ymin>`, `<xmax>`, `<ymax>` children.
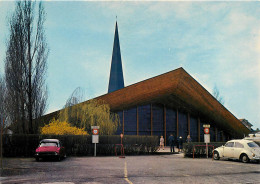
<box><xmin>42</xmin><ymin>23</ymin><xmax>249</xmax><ymax>142</ymax></box>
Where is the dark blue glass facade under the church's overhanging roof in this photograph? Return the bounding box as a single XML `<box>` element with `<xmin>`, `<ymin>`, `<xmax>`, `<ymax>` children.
<box><xmin>116</xmin><ymin>104</ymin><xmax>228</xmax><ymax>144</ymax></box>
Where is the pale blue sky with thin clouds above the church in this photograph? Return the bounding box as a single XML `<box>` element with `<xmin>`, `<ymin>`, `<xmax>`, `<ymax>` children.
<box><xmin>0</xmin><ymin>1</ymin><xmax>260</xmax><ymax>129</ymax></box>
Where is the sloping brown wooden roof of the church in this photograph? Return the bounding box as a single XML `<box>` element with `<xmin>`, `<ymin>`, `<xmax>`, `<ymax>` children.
<box><xmin>94</xmin><ymin>68</ymin><xmax>249</xmax><ymax>137</ymax></box>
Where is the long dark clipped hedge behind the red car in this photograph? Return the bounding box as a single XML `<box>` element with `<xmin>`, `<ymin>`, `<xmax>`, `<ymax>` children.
<box><xmin>3</xmin><ymin>135</ymin><xmax>159</xmax><ymax>157</ymax></box>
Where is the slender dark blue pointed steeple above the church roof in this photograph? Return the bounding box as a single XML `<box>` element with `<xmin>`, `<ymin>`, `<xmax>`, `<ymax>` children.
<box><xmin>108</xmin><ymin>22</ymin><xmax>125</xmax><ymax>93</ymax></box>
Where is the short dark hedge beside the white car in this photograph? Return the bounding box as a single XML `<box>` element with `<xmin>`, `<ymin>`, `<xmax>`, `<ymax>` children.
<box><xmin>183</xmin><ymin>142</ymin><xmax>226</xmax><ymax>158</ymax></box>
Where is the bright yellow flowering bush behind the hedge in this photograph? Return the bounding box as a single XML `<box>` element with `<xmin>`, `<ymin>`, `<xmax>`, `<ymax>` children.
<box><xmin>41</xmin><ymin>119</ymin><xmax>88</xmax><ymax>135</ymax></box>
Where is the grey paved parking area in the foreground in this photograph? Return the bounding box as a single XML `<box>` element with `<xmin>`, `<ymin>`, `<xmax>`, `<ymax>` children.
<box><xmin>0</xmin><ymin>154</ymin><xmax>260</xmax><ymax>184</ymax></box>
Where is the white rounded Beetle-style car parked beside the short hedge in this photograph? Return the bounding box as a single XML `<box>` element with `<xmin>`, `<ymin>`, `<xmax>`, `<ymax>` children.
<box><xmin>213</xmin><ymin>139</ymin><xmax>260</xmax><ymax>163</ymax></box>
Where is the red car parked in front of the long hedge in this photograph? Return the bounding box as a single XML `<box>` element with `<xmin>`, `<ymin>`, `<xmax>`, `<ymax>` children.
<box><xmin>35</xmin><ymin>139</ymin><xmax>66</xmax><ymax>161</ymax></box>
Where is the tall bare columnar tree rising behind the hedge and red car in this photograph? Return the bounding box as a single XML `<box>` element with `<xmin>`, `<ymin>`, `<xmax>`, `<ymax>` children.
<box><xmin>5</xmin><ymin>0</ymin><xmax>48</xmax><ymax>133</ymax></box>
